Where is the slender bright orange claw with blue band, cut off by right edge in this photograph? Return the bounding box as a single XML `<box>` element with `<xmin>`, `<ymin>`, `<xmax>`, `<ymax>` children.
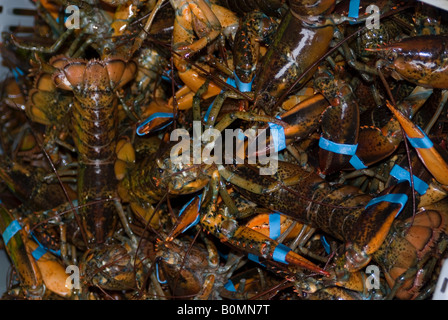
<box><xmin>387</xmin><ymin>102</ymin><xmax>448</xmax><ymax>185</ymax></box>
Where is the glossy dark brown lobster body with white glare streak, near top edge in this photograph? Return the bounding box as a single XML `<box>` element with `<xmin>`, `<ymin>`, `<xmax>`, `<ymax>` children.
<box><xmin>254</xmin><ymin>1</ymin><xmax>335</xmax><ymax>116</ymax></box>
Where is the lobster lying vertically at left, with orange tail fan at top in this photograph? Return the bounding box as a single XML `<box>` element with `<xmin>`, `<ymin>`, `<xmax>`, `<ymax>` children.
<box><xmin>50</xmin><ymin>58</ymin><xmax>136</xmax><ymax>243</ymax></box>
